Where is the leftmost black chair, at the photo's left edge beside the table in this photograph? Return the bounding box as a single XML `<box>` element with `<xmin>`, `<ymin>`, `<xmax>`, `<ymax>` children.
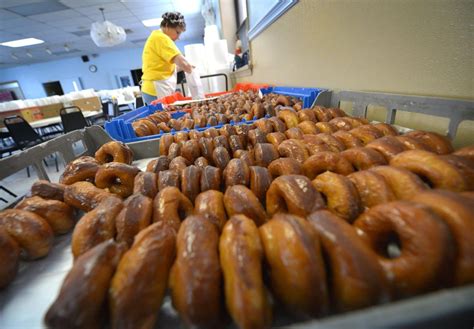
<box><xmin>3</xmin><ymin>115</ymin><xmax>59</xmax><ymax>177</ymax></box>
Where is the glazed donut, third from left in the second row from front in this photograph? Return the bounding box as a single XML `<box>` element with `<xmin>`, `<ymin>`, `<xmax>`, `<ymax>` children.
<box><xmin>153</xmin><ymin>186</ymin><xmax>194</xmax><ymax>232</ymax></box>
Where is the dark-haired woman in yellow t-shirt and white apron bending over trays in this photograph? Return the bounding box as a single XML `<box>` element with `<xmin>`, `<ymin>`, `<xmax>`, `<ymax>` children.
<box><xmin>141</xmin><ymin>12</ymin><xmax>193</xmax><ymax>104</ymax></box>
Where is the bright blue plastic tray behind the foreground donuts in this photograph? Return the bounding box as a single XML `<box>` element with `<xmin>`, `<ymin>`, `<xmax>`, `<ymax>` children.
<box><xmin>105</xmin><ymin>87</ymin><xmax>325</xmax><ymax>143</ymax></box>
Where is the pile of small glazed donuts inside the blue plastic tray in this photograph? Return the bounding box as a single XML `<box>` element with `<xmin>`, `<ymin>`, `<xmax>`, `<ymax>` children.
<box><xmin>132</xmin><ymin>91</ymin><xmax>301</xmax><ymax>137</ymax></box>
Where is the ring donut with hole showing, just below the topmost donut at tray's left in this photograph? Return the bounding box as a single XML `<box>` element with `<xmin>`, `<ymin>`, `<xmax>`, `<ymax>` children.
<box><xmin>95</xmin><ymin>162</ymin><xmax>140</xmax><ymax>198</ymax></box>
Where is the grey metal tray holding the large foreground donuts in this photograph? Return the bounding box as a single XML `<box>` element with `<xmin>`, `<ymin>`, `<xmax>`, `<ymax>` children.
<box><xmin>0</xmin><ymin>126</ymin><xmax>474</xmax><ymax>329</ymax></box>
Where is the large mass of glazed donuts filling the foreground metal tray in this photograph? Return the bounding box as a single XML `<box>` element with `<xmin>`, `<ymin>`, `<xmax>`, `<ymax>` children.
<box><xmin>0</xmin><ymin>104</ymin><xmax>474</xmax><ymax>328</ymax></box>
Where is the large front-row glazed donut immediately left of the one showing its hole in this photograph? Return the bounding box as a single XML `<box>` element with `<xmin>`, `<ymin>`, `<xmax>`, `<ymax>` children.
<box><xmin>308</xmin><ymin>210</ymin><xmax>390</xmax><ymax>312</ymax></box>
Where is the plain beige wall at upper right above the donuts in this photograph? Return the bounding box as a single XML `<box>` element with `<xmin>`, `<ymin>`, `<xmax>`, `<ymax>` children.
<box><xmin>238</xmin><ymin>0</ymin><xmax>474</xmax><ymax>144</ymax></box>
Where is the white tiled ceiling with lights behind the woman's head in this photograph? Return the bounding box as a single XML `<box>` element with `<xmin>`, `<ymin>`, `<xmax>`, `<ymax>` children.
<box><xmin>0</xmin><ymin>0</ymin><xmax>205</xmax><ymax>69</ymax></box>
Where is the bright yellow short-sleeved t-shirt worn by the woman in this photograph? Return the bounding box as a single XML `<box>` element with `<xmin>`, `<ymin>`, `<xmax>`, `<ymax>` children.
<box><xmin>142</xmin><ymin>30</ymin><xmax>181</xmax><ymax>96</ymax></box>
